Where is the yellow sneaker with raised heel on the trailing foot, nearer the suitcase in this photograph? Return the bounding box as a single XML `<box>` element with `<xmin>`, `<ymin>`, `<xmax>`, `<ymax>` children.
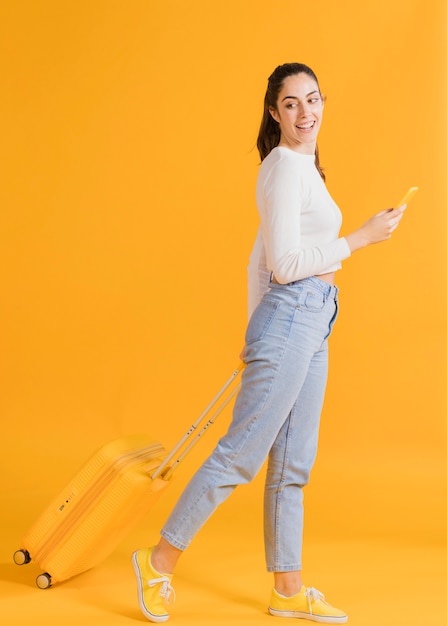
<box><xmin>132</xmin><ymin>548</ymin><xmax>175</xmax><ymax>622</ymax></box>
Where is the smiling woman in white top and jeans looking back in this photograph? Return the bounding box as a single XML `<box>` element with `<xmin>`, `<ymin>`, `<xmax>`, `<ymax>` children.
<box><xmin>132</xmin><ymin>63</ymin><xmax>405</xmax><ymax>624</ymax></box>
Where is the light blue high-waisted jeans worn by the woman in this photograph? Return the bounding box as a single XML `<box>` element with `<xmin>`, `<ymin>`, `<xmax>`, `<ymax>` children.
<box><xmin>161</xmin><ymin>277</ymin><xmax>338</xmax><ymax>572</ymax></box>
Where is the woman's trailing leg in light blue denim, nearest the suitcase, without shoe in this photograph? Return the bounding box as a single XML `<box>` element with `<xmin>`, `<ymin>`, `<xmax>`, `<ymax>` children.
<box><xmin>162</xmin><ymin>292</ymin><xmax>322</xmax><ymax>550</ymax></box>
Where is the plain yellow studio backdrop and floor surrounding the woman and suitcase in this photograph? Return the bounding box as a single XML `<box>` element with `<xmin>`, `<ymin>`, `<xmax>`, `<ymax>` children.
<box><xmin>0</xmin><ymin>0</ymin><xmax>447</xmax><ymax>626</ymax></box>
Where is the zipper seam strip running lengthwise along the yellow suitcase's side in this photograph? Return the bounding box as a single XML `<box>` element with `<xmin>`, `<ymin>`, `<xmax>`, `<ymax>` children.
<box><xmin>33</xmin><ymin>446</ymin><xmax>164</xmax><ymax>563</ymax></box>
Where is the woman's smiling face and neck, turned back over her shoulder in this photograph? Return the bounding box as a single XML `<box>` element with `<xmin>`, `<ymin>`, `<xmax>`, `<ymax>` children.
<box><xmin>270</xmin><ymin>73</ymin><xmax>324</xmax><ymax>154</ymax></box>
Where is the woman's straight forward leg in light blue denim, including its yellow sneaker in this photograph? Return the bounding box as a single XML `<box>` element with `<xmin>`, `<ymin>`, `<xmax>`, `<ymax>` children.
<box><xmin>265</xmin><ymin>288</ymin><xmax>348</xmax><ymax>624</ymax></box>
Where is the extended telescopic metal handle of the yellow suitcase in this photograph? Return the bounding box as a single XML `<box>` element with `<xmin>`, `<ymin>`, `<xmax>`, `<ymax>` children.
<box><xmin>151</xmin><ymin>361</ymin><xmax>245</xmax><ymax>480</ymax></box>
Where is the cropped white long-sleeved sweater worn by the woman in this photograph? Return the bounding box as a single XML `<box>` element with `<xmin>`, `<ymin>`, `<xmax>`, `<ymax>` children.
<box><xmin>248</xmin><ymin>147</ymin><xmax>351</xmax><ymax>316</ymax></box>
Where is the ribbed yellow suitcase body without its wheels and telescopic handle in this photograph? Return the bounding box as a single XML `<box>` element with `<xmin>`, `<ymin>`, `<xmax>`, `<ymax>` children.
<box><xmin>16</xmin><ymin>435</ymin><xmax>168</xmax><ymax>583</ymax></box>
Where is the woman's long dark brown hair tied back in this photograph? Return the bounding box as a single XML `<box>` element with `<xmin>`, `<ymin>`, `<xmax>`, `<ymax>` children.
<box><xmin>256</xmin><ymin>63</ymin><xmax>326</xmax><ymax>180</ymax></box>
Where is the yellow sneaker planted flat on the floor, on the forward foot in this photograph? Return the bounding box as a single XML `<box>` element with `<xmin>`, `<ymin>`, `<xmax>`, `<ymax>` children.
<box><xmin>269</xmin><ymin>585</ymin><xmax>348</xmax><ymax>624</ymax></box>
